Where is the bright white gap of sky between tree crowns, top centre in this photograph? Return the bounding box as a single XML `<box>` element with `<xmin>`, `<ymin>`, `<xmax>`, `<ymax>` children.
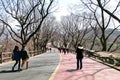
<box><xmin>54</xmin><ymin>0</ymin><xmax>80</xmax><ymax>20</ymax></box>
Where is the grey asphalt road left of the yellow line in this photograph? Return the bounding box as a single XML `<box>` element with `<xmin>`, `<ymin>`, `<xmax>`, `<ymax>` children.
<box><xmin>0</xmin><ymin>51</ymin><xmax>60</xmax><ymax>80</ymax></box>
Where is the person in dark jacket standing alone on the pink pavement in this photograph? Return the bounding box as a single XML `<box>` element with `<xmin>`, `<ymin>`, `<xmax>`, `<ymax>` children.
<box><xmin>76</xmin><ymin>47</ymin><xmax>84</xmax><ymax>70</ymax></box>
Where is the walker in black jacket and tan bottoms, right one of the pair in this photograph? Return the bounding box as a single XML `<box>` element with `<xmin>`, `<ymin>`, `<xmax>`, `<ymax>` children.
<box><xmin>21</xmin><ymin>46</ymin><xmax>29</xmax><ymax>69</ymax></box>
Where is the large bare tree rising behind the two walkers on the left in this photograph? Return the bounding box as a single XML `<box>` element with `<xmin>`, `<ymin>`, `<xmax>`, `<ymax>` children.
<box><xmin>0</xmin><ymin>0</ymin><xmax>54</xmax><ymax>46</ymax></box>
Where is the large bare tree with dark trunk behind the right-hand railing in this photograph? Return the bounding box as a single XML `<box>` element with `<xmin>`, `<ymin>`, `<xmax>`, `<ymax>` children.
<box><xmin>81</xmin><ymin>0</ymin><xmax>120</xmax><ymax>51</ymax></box>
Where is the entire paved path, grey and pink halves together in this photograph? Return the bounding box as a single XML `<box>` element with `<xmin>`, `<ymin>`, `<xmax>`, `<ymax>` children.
<box><xmin>0</xmin><ymin>51</ymin><xmax>120</xmax><ymax>80</ymax></box>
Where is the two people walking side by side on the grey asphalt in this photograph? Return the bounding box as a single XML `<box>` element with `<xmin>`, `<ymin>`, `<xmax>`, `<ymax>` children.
<box><xmin>12</xmin><ymin>46</ymin><xmax>29</xmax><ymax>71</ymax></box>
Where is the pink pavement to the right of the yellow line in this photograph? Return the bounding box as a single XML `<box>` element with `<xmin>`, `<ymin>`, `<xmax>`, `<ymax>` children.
<box><xmin>53</xmin><ymin>53</ymin><xmax>120</xmax><ymax>80</ymax></box>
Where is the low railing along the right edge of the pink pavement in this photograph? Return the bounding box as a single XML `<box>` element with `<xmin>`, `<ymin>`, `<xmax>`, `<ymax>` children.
<box><xmin>85</xmin><ymin>50</ymin><xmax>120</xmax><ymax>69</ymax></box>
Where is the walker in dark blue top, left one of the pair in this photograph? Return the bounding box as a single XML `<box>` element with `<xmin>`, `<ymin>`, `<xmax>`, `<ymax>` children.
<box><xmin>12</xmin><ymin>46</ymin><xmax>21</xmax><ymax>71</ymax></box>
